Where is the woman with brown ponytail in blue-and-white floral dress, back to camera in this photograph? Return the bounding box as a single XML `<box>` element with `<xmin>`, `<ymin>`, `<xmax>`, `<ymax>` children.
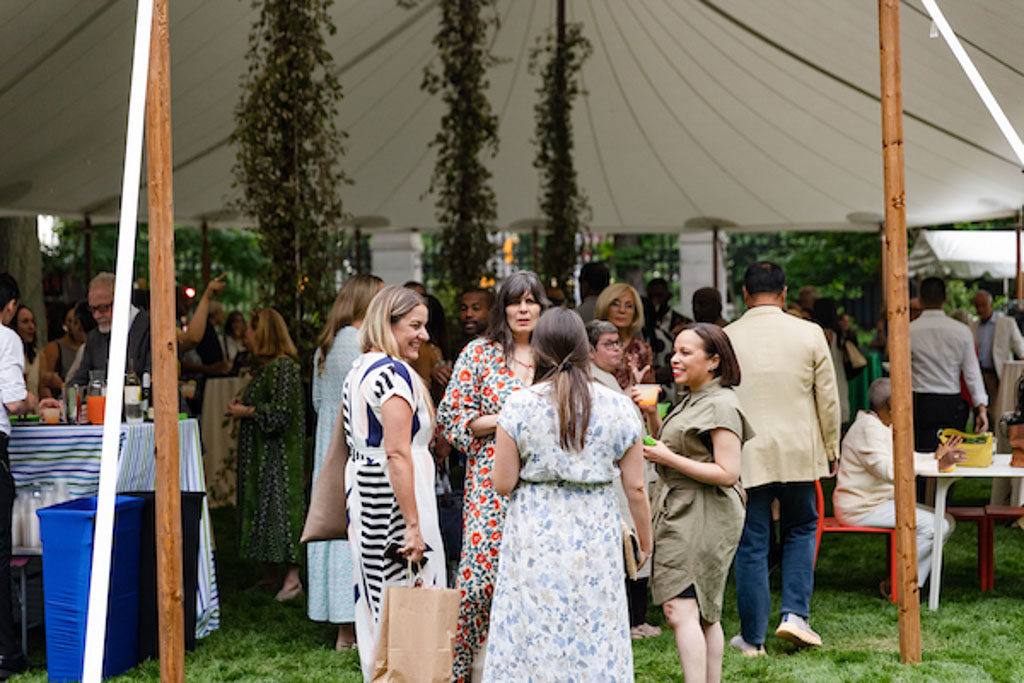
<box><xmin>483</xmin><ymin>308</ymin><xmax>651</xmax><ymax>681</ymax></box>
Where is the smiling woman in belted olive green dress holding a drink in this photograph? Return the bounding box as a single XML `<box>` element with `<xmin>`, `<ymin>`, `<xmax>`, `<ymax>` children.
<box><xmin>642</xmin><ymin>323</ymin><xmax>754</xmax><ymax>681</ymax></box>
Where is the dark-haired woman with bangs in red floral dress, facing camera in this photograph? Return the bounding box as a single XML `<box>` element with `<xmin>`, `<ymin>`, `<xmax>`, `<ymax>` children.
<box><xmin>437</xmin><ymin>270</ymin><xmax>549</xmax><ymax>683</ymax></box>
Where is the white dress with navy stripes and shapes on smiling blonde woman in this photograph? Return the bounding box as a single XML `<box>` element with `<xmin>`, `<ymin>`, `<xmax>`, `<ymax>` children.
<box><xmin>342</xmin><ymin>352</ymin><xmax>444</xmax><ymax>681</ymax></box>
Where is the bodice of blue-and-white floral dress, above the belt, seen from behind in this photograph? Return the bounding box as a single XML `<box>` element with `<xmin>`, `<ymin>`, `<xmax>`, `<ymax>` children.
<box><xmin>498</xmin><ymin>382</ymin><xmax>643</xmax><ymax>484</ymax></box>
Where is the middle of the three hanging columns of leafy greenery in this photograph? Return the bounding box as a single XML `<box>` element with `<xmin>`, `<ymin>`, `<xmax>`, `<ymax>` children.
<box><xmin>422</xmin><ymin>0</ymin><xmax>499</xmax><ymax>290</ymax></box>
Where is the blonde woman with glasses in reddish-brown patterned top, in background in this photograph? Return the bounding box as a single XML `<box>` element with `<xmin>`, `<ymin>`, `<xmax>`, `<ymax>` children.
<box><xmin>594</xmin><ymin>283</ymin><xmax>654</xmax><ymax>389</ymax></box>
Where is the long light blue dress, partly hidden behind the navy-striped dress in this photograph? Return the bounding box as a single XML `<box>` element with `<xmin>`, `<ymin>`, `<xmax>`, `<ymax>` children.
<box><xmin>306</xmin><ymin>326</ymin><xmax>359</xmax><ymax>624</ymax></box>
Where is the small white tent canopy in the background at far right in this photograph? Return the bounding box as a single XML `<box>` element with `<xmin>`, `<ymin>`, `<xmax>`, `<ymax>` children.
<box><xmin>907</xmin><ymin>230</ymin><xmax>1017</xmax><ymax>280</ymax></box>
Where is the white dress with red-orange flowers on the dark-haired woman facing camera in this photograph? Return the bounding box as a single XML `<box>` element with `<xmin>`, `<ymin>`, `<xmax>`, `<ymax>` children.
<box><xmin>437</xmin><ymin>339</ymin><xmax>523</xmax><ymax>683</ymax></box>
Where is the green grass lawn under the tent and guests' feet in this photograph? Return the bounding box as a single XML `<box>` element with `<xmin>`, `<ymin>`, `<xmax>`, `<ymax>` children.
<box><xmin>12</xmin><ymin>479</ymin><xmax>1024</xmax><ymax>683</ymax></box>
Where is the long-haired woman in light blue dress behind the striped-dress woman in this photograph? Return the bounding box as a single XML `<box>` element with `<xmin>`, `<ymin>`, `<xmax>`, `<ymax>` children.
<box><xmin>306</xmin><ymin>275</ymin><xmax>383</xmax><ymax>650</ymax></box>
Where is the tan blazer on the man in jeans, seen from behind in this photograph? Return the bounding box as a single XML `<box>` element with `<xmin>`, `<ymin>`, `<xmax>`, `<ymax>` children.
<box><xmin>725</xmin><ymin>306</ymin><xmax>841</xmax><ymax>488</ymax></box>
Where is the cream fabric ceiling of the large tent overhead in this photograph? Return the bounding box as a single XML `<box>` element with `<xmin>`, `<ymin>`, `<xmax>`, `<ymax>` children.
<box><xmin>0</xmin><ymin>0</ymin><xmax>1024</xmax><ymax>232</ymax></box>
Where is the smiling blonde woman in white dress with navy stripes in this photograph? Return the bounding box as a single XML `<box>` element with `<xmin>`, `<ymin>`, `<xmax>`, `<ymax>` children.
<box><xmin>332</xmin><ymin>287</ymin><xmax>444</xmax><ymax>681</ymax></box>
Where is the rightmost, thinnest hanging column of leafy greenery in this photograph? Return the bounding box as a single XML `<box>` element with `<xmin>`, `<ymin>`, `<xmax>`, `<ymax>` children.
<box><xmin>529</xmin><ymin>24</ymin><xmax>594</xmax><ymax>295</ymax></box>
